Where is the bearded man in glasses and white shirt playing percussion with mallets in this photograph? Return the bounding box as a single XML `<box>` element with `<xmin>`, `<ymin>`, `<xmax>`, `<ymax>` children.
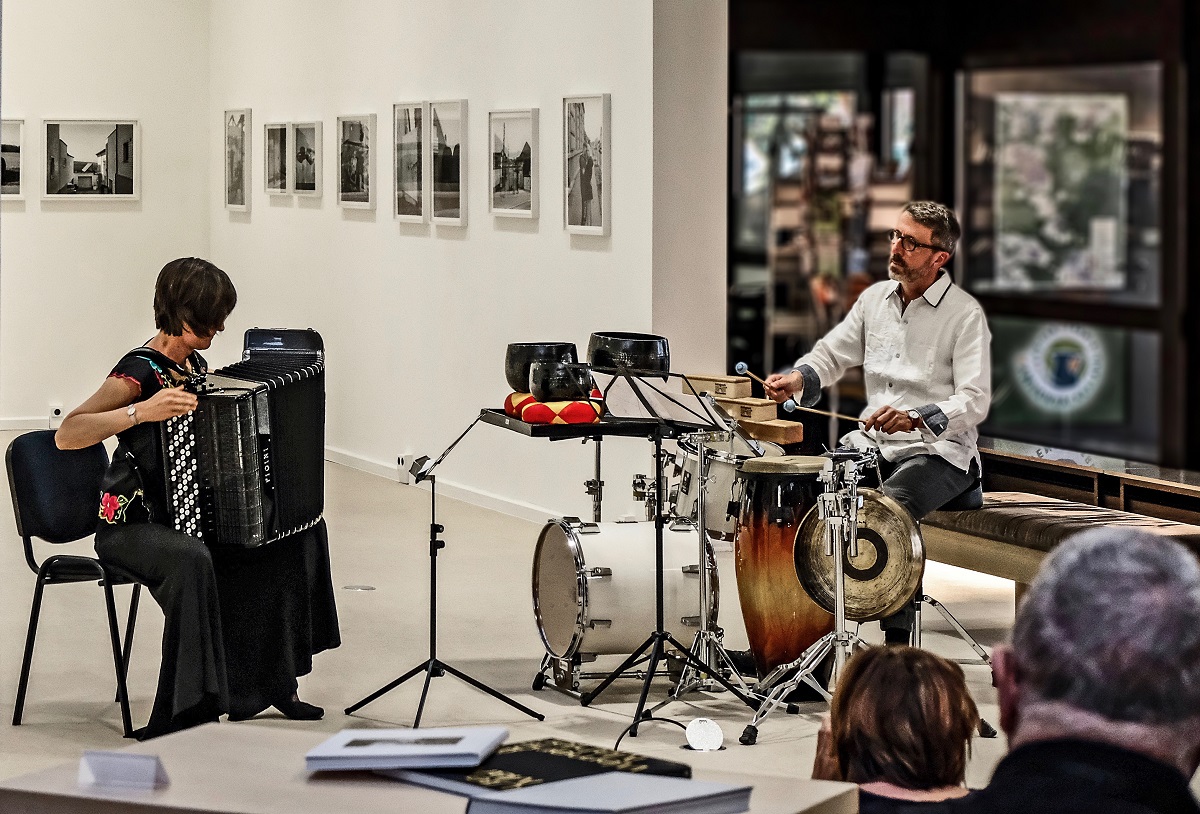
<box><xmin>766</xmin><ymin>200</ymin><xmax>991</xmax><ymax>642</ymax></box>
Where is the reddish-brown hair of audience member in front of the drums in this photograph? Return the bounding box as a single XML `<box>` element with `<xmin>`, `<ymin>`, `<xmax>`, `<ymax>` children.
<box><xmin>830</xmin><ymin>647</ymin><xmax>979</xmax><ymax>789</ymax></box>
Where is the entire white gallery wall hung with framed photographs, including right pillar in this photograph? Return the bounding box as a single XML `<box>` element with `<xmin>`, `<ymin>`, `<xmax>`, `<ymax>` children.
<box><xmin>0</xmin><ymin>0</ymin><xmax>727</xmax><ymax>517</ymax></box>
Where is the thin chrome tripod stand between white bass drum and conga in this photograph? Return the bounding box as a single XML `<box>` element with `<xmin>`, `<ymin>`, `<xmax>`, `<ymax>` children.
<box><xmin>652</xmin><ymin>432</ymin><xmax>752</xmax><ymax>712</ymax></box>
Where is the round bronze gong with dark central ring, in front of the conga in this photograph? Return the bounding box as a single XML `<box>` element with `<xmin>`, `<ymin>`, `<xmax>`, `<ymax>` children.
<box><xmin>794</xmin><ymin>489</ymin><xmax>925</xmax><ymax>622</ymax></box>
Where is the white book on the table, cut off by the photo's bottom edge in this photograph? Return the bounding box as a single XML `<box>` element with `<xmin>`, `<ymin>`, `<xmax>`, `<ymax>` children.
<box><xmin>467</xmin><ymin>772</ymin><xmax>751</xmax><ymax>814</ymax></box>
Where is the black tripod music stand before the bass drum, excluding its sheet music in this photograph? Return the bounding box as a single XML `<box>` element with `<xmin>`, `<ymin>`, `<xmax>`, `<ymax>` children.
<box><xmin>580</xmin><ymin>367</ymin><xmax>757</xmax><ymax>737</ymax></box>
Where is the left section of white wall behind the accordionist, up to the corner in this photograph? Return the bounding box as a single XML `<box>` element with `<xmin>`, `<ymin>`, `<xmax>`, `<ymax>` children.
<box><xmin>0</xmin><ymin>0</ymin><xmax>212</xmax><ymax>429</ymax></box>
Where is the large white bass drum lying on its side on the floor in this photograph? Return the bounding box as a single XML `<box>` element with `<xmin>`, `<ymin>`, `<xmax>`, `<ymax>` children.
<box><xmin>533</xmin><ymin>517</ymin><xmax>715</xmax><ymax>659</ymax></box>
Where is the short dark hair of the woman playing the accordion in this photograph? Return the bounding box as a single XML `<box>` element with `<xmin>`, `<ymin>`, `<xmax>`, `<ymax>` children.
<box><xmin>154</xmin><ymin>257</ymin><xmax>238</xmax><ymax>336</ymax></box>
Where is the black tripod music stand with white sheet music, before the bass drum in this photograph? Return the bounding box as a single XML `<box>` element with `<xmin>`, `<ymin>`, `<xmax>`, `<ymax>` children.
<box><xmin>580</xmin><ymin>367</ymin><xmax>758</xmax><ymax>737</ymax></box>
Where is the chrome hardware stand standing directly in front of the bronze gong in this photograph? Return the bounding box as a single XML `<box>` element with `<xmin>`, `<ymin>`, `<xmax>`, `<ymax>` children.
<box><xmin>738</xmin><ymin>451</ymin><xmax>874</xmax><ymax>746</ymax></box>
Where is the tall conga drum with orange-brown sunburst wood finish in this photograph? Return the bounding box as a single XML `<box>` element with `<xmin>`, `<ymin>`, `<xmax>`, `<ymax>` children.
<box><xmin>733</xmin><ymin>455</ymin><xmax>833</xmax><ymax>678</ymax></box>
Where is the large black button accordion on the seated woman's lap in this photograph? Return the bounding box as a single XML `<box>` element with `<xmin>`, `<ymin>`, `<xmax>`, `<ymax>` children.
<box><xmin>161</xmin><ymin>328</ymin><xmax>325</xmax><ymax>546</ymax></box>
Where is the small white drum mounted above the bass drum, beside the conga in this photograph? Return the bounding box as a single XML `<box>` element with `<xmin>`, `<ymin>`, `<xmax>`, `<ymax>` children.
<box><xmin>671</xmin><ymin>432</ymin><xmax>784</xmax><ymax>541</ymax></box>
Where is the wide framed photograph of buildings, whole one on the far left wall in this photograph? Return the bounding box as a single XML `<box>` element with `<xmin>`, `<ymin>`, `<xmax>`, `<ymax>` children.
<box><xmin>44</xmin><ymin>119</ymin><xmax>140</xmax><ymax>200</ymax></box>
